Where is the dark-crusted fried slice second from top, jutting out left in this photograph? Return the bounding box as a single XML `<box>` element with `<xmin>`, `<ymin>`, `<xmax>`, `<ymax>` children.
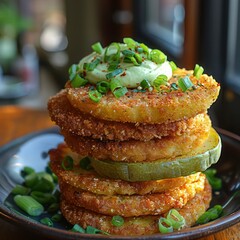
<box><xmin>48</xmin><ymin>89</ymin><xmax>207</xmax><ymax>141</ymax></box>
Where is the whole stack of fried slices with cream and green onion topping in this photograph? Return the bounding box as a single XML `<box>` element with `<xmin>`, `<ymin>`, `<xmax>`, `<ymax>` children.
<box><xmin>48</xmin><ymin>38</ymin><xmax>221</xmax><ymax>236</ymax></box>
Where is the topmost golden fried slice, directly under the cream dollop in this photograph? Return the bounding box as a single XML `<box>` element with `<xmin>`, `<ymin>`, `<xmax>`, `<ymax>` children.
<box><xmin>67</xmin><ymin>70</ymin><xmax>220</xmax><ymax>124</ymax></box>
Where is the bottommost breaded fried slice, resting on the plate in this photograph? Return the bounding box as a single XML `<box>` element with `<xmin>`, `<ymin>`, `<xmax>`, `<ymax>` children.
<box><xmin>61</xmin><ymin>181</ymin><xmax>212</xmax><ymax>236</ymax></box>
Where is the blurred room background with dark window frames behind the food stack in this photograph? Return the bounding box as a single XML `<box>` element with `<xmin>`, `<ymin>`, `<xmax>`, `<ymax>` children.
<box><xmin>0</xmin><ymin>0</ymin><xmax>240</xmax><ymax>134</ymax></box>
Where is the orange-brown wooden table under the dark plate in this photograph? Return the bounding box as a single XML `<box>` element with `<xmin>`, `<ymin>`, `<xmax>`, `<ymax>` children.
<box><xmin>0</xmin><ymin>106</ymin><xmax>240</xmax><ymax>240</ymax></box>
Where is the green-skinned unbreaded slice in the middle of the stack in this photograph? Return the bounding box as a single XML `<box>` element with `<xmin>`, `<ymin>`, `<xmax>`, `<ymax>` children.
<box><xmin>91</xmin><ymin>128</ymin><xmax>222</xmax><ymax>182</ymax></box>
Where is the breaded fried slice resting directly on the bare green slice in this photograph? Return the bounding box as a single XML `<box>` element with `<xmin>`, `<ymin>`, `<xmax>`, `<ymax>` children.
<box><xmin>62</xmin><ymin>117</ymin><xmax>211</xmax><ymax>162</ymax></box>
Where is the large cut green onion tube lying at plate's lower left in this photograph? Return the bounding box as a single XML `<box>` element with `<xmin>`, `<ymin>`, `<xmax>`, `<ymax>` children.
<box><xmin>13</xmin><ymin>195</ymin><xmax>44</xmax><ymax>216</ymax></box>
